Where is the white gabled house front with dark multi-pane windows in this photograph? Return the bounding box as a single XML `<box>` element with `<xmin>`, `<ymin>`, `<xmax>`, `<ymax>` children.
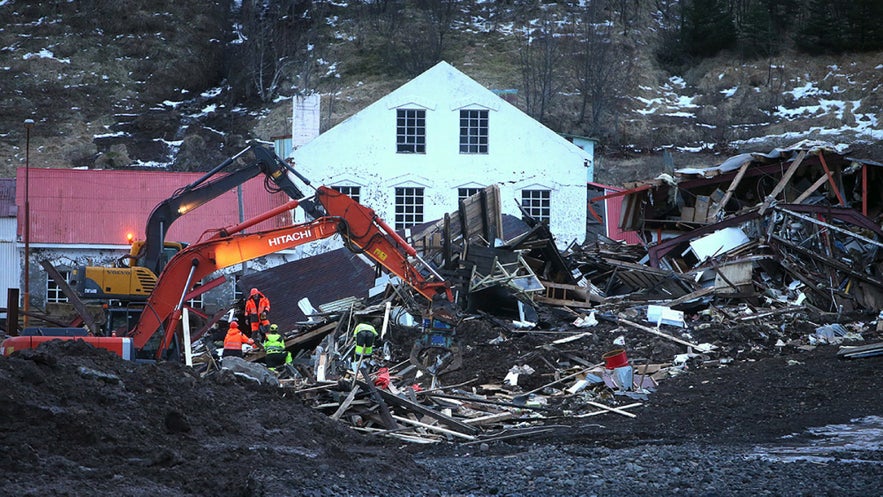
<box><xmin>291</xmin><ymin>62</ymin><xmax>593</xmax><ymax>247</ymax></box>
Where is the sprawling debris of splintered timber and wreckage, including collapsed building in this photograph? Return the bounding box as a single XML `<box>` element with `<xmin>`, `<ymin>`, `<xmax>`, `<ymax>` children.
<box><xmin>193</xmin><ymin>143</ymin><xmax>883</xmax><ymax>443</ymax></box>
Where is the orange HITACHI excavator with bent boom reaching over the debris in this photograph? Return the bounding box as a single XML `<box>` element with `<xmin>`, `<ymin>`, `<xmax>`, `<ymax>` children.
<box><xmin>2</xmin><ymin>182</ymin><xmax>453</xmax><ymax>359</ymax></box>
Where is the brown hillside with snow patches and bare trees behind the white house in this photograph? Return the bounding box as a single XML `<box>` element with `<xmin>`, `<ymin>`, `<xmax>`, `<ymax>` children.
<box><xmin>0</xmin><ymin>0</ymin><xmax>883</xmax><ymax>183</ymax></box>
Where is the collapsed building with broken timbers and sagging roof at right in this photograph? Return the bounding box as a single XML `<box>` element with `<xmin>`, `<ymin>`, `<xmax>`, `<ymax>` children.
<box><xmin>602</xmin><ymin>138</ymin><xmax>883</xmax><ymax>312</ymax></box>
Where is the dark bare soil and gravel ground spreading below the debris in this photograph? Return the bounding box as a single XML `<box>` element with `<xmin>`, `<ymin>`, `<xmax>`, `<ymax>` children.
<box><xmin>0</xmin><ymin>308</ymin><xmax>883</xmax><ymax>496</ymax></box>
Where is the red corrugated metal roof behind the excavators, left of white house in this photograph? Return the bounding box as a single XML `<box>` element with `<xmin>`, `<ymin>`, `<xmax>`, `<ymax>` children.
<box><xmin>15</xmin><ymin>167</ymin><xmax>291</xmax><ymax>245</ymax></box>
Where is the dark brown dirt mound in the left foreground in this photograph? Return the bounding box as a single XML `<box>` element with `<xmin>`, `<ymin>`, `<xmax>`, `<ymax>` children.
<box><xmin>0</xmin><ymin>342</ymin><xmax>422</xmax><ymax>496</ymax></box>
